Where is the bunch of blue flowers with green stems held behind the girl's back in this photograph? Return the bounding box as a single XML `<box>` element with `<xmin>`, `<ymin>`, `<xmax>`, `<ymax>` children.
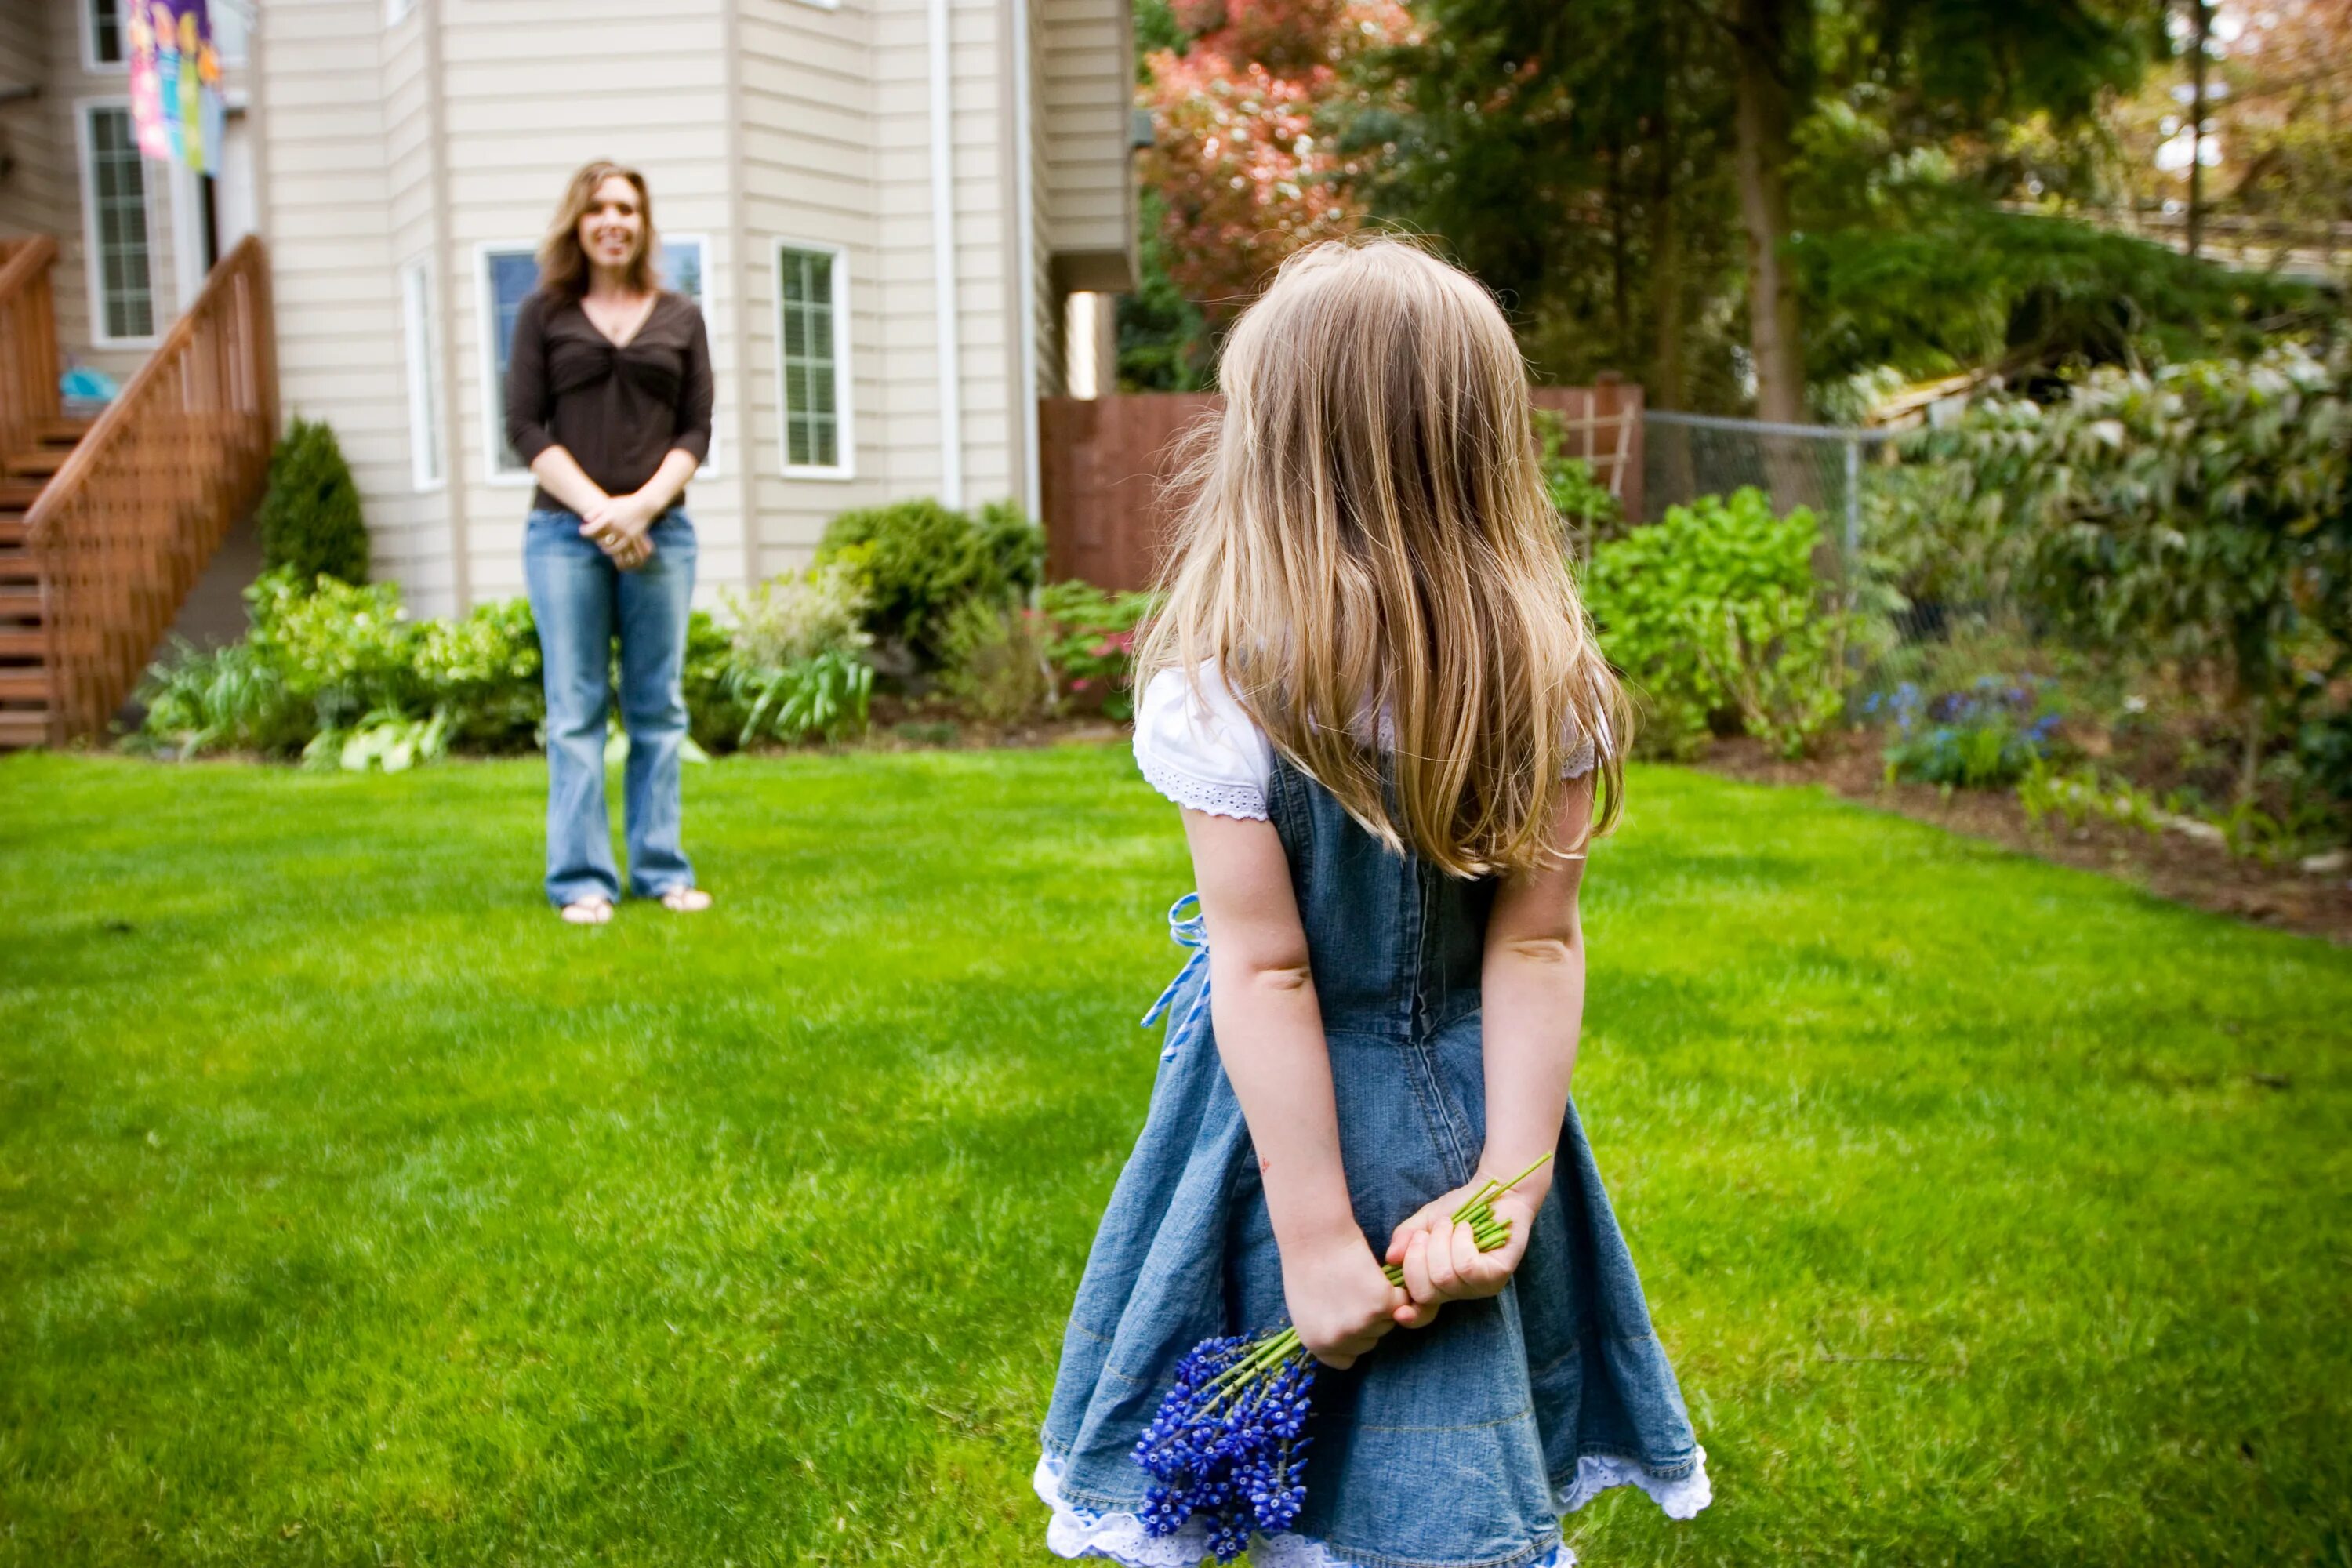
<box><xmin>1136</xmin><ymin>1154</ymin><xmax>1550</xmax><ymax>1563</ymax></box>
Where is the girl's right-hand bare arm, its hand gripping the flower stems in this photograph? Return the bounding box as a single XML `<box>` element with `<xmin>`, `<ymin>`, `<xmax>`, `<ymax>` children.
<box><xmin>1388</xmin><ymin>774</ymin><xmax>1592</xmax><ymax>1328</ymax></box>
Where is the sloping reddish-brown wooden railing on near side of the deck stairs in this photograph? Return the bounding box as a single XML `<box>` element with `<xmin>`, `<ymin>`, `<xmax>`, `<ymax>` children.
<box><xmin>26</xmin><ymin>238</ymin><xmax>278</xmax><ymax>743</ymax></box>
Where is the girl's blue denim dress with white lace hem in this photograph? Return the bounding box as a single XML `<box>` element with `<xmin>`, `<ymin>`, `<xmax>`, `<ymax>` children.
<box><xmin>1035</xmin><ymin>760</ymin><xmax>1710</xmax><ymax>1568</ymax></box>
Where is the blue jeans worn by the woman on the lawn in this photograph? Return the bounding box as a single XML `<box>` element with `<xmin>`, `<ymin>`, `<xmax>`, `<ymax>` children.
<box><xmin>522</xmin><ymin>508</ymin><xmax>694</xmax><ymax>907</ymax></box>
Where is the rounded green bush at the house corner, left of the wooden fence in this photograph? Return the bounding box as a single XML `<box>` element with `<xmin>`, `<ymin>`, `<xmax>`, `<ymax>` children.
<box><xmin>816</xmin><ymin>501</ymin><xmax>1044</xmax><ymax>670</ymax></box>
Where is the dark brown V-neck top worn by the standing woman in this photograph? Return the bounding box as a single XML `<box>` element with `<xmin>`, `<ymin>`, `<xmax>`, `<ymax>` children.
<box><xmin>506</xmin><ymin>289</ymin><xmax>710</xmax><ymax>510</ymax></box>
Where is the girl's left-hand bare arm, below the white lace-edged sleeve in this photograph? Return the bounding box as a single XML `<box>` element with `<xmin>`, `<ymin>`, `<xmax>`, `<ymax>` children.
<box><xmin>1183</xmin><ymin>808</ymin><xmax>1404</xmax><ymax>1366</ymax></box>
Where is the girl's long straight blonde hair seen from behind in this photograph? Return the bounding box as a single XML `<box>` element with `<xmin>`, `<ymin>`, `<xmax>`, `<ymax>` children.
<box><xmin>1138</xmin><ymin>238</ymin><xmax>1632</xmax><ymax>877</ymax></box>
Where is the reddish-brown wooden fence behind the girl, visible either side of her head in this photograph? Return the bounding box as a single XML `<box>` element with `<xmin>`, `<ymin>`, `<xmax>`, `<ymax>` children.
<box><xmin>1037</xmin><ymin>381</ymin><xmax>1642</xmax><ymax>588</ymax></box>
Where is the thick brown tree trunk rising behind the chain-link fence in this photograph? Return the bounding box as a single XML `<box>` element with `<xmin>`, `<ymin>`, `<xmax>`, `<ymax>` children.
<box><xmin>1733</xmin><ymin>0</ymin><xmax>1804</xmax><ymax>423</ymax></box>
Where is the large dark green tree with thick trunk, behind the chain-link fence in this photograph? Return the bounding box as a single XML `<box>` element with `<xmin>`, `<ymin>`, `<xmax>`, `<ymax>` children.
<box><xmin>1355</xmin><ymin>0</ymin><xmax>2147</xmax><ymax>419</ymax></box>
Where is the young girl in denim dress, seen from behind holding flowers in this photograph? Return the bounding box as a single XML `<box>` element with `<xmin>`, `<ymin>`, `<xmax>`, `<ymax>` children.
<box><xmin>1035</xmin><ymin>240</ymin><xmax>1710</xmax><ymax>1568</ymax></box>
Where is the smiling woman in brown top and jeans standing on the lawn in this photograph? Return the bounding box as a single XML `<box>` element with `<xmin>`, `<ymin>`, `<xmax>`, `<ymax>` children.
<box><xmin>506</xmin><ymin>162</ymin><xmax>710</xmax><ymax>926</ymax></box>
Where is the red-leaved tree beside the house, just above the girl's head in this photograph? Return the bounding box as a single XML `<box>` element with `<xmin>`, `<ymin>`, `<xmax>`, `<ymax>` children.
<box><xmin>1141</xmin><ymin>0</ymin><xmax>1414</xmax><ymax>325</ymax></box>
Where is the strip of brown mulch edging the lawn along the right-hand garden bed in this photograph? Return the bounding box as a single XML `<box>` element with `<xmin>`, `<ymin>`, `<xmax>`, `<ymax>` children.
<box><xmin>1700</xmin><ymin>739</ymin><xmax>2352</xmax><ymax>945</ymax></box>
